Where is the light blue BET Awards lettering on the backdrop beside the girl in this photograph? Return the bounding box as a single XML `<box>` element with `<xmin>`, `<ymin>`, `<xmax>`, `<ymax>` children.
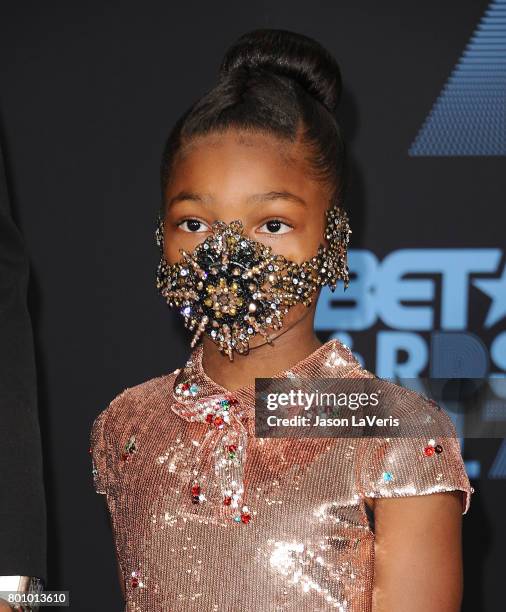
<box><xmin>315</xmin><ymin>248</ymin><xmax>506</xmax><ymax>478</ymax></box>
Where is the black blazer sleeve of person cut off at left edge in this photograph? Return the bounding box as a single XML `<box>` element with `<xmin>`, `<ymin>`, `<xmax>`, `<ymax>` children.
<box><xmin>0</xmin><ymin>140</ymin><xmax>47</xmax><ymax>582</ymax></box>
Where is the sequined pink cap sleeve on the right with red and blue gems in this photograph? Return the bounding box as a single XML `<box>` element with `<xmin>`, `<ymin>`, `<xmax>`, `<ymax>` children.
<box><xmin>359</xmin><ymin>400</ymin><xmax>474</xmax><ymax>514</ymax></box>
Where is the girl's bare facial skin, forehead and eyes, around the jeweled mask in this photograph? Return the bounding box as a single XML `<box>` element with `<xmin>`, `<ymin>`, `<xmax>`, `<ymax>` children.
<box><xmin>164</xmin><ymin>130</ymin><xmax>329</xmax><ymax>347</ymax></box>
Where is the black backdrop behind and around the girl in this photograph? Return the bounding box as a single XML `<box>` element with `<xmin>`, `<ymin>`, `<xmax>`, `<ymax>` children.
<box><xmin>0</xmin><ymin>0</ymin><xmax>506</xmax><ymax>612</ymax></box>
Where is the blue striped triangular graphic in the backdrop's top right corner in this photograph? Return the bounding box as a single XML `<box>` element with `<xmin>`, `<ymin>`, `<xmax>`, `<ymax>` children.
<box><xmin>408</xmin><ymin>0</ymin><xmax>506</xmax><ymax>156</ymax></box>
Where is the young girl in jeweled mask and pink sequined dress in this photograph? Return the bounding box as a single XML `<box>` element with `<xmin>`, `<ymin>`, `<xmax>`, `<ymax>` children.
<box><xmin>91</xmin><ymin>30</ymin><xmax>473</xmax><ymax>612</ymax></box>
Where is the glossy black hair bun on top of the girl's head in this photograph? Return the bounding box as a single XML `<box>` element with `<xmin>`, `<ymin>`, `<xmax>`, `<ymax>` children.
<box><xmin>220</xmin><ymin>29</ymin><xmax>342</xmax><ymax>113</ymax></box>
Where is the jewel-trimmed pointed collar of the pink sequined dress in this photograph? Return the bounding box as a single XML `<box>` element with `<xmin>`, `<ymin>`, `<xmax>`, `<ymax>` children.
<box><xmin>172</xmin><ymin>339</ymin><xmax>361</xmax><ymax>420</ymax></box>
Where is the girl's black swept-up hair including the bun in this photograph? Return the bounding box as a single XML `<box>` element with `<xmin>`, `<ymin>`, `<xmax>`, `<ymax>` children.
<box><xmin>161</xmin><ymin>29</ymin><xmax>347</xmax><ymax>218</ymax></box>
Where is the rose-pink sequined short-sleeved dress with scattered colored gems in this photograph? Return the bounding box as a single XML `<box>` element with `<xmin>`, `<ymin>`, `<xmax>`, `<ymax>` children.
<box><xmin>90</xmin><ymin>340</ymin><xmax>474</xmax><ymax>612</ymax></box>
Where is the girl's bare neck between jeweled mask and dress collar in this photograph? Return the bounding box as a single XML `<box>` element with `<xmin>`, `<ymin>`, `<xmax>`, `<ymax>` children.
<box><xmin>202</xmin><ymin>310</ymin><xmax>322</xmax><ymax>391</ymax></box>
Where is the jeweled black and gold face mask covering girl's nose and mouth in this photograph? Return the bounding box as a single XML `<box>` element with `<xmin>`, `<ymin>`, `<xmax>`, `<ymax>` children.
<box><xmin>155</xmin><ymin>207</ymin><xmax>351</xmax><ymax>360</ymax></box>
